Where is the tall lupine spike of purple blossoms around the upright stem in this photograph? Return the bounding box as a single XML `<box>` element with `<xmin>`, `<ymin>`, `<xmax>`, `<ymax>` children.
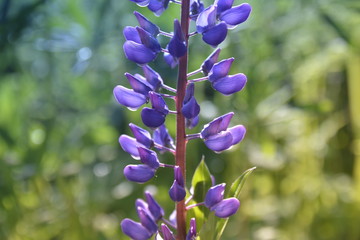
<box><xmin>113</xmin><ymin>0</ymin><xmax>251</xmax><ymax>240</ymax></box>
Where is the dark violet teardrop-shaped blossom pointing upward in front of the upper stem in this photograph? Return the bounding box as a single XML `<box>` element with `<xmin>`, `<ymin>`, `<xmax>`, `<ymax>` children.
<box><xmin>167</xmin><ymin>19</ymin><xmax>187</xmax><ymax>58</ymax></box>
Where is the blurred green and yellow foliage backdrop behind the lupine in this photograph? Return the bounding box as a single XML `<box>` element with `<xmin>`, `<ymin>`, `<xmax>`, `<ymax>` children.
<box><xmin>0</xmin><ymin>0</ymin><xmax>360</xmax><ymax>240</ymax></box>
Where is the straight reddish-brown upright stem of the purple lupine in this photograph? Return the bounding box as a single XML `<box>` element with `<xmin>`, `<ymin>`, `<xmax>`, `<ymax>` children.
<box><xmin>175</xmin><ymin>0</ymin><xmax>190</xmax><ymax>240</ymax></box>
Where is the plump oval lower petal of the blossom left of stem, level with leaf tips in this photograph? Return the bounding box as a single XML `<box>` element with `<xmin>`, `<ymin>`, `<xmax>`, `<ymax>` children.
<box><xmin>124</xmin><ymin>164</ymin><xmax>155</xmax><ymax>183</ymax></box>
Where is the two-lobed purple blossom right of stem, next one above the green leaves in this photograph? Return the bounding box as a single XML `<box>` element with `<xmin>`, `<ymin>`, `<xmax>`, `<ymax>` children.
<box><xmin>200</xmin><ymin>112</ymin><xmax>246</xmax><ymax>152</ymax></box>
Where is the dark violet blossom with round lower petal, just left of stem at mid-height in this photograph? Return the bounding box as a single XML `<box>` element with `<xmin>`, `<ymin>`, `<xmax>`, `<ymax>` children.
<box><xmin>141</xmin><ymin>92</ymin><xmax>169</xmax><ymax>128</ymax></box>
